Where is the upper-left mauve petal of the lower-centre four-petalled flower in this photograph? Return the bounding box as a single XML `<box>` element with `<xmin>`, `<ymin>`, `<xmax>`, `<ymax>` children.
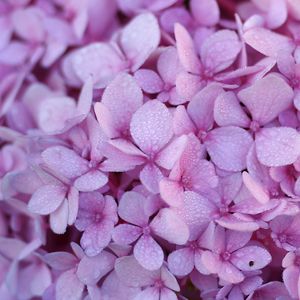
<box><xmin>118</xmin><ymin>191</ymin><xmax>148</xmax><ymax>226</ymax></box>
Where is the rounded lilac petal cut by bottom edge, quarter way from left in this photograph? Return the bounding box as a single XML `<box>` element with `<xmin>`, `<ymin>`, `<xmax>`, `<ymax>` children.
<box><xmin>55</xmin><ymin>269</ymin><xmax>84</xmax><ymax>300</ymax></box>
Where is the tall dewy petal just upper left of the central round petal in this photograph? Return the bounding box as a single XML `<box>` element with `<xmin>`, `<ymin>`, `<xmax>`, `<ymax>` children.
<box><xmin>98</xmin><ymin>73</ymin><xmax>143</xmax><ymax>136</ymax></box>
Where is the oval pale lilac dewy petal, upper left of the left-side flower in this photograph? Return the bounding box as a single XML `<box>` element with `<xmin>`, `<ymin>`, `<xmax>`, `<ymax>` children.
<box><xmin>42</xmin><ymin>146</ymin><xmax>88</xmax><ymax>178</ymax></box>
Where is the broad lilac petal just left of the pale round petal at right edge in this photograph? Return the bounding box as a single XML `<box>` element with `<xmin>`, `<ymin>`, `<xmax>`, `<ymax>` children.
<box><xmin>204</xmin><ymin>126</ymin><xmax>253</xmax><ymax>171</ymax></box>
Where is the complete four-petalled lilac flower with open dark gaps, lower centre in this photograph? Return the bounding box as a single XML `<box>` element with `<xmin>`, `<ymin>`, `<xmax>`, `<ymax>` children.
<box><xmin>112</xmin><ymin>192</ymin><xmax>189</xmax><ymax>270</ymax></box>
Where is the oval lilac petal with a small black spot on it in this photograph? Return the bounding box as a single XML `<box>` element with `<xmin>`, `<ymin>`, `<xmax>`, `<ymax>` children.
<box><xmin>230</xmin><ymin>246</ymin><xmax>272</xmax><ymax>271</ymax></box>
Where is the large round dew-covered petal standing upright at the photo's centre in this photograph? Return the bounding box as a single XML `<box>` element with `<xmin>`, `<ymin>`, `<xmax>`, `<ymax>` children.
<box><xmin>130</xmin><ymin>100</ymin><xmax>173</xmax><ymax>154</ymax></box>
